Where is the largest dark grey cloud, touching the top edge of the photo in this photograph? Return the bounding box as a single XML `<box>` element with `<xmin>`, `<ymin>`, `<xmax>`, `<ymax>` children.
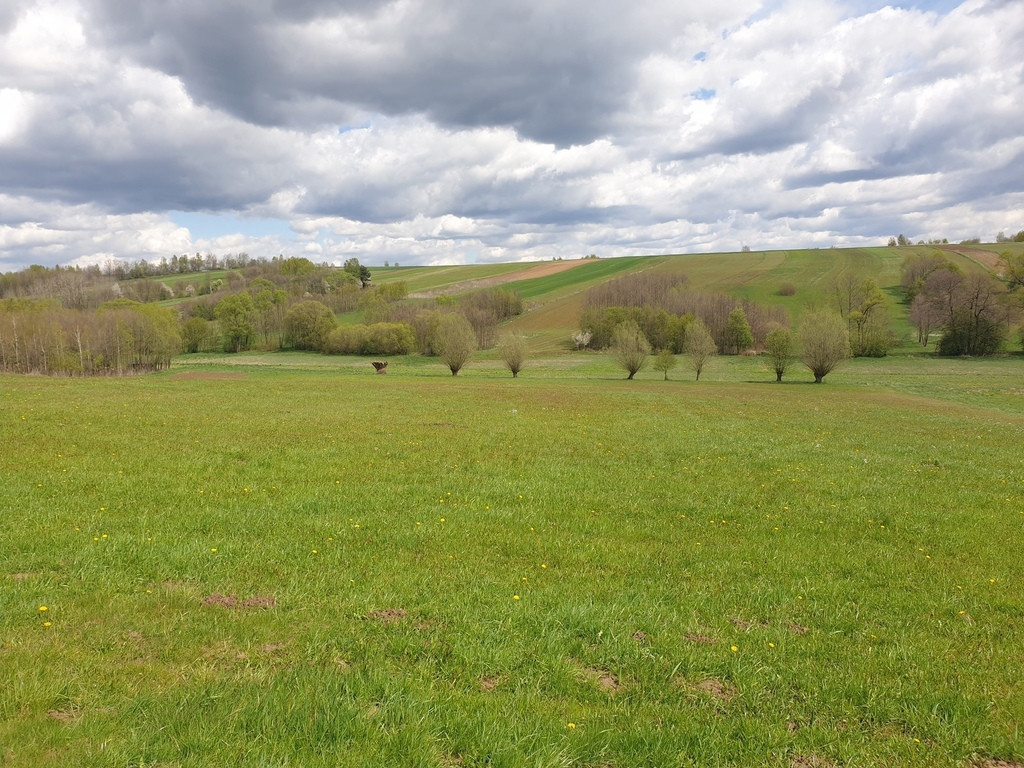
<box><xmin>88</xmin><ymin>0</ymin><xmax>722</xmax><ymax>145</ymax></box>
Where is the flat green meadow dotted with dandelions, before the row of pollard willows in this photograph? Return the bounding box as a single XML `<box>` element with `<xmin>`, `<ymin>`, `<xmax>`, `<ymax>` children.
<box><xmin>0</xmin><ymin>353</ymin><xmax>1024</xmax><ymax>767</ymax></box>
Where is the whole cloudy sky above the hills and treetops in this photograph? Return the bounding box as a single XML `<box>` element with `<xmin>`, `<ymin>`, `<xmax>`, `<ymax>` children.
<box><xmin>0</xmin><ymin>0</ymin><xmax>1024</xmax><ymax>271</ymax></box>
